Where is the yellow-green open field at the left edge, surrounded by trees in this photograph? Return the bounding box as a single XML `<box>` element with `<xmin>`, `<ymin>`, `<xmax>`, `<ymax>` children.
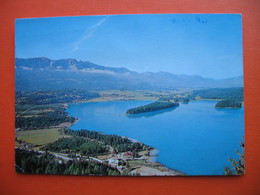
<box><xmin>16</xmin><ymin>128</ymin><xmax>69</xmax><ymax>146</ymax></box>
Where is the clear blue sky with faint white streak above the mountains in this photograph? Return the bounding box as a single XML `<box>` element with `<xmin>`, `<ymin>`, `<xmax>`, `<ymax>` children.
<box><xmin>15</xmin><ymin>14</ymin><xmax>243</xmax><ymax>79</ymax></box>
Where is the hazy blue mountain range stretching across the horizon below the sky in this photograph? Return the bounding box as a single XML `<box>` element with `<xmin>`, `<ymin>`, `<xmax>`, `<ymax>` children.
<box><xmin>15</xmin><ymin>57</ymin><xmax>243</xmax><ymax>91</ymax></box>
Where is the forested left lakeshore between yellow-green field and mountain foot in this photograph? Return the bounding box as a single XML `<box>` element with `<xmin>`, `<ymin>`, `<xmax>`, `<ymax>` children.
<box><xmin>15</xmin><ymin>89</ymin><xmax>99</xmax><ymax>130</ymax></box>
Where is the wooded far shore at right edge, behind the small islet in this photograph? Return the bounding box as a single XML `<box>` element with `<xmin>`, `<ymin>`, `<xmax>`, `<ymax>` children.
<box><xmin>190</xmin><ymin>87</ymin><xmax>244</xmax><ymax>102</ymax></box>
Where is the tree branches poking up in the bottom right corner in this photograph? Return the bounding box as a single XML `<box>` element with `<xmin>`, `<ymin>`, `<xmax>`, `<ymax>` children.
<box><xmin>225</xmin><ymin>142</ymin><xmax>245</xmax><ymax>175</ymax></box>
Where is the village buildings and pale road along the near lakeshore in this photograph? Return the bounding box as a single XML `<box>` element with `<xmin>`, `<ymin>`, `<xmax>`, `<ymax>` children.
<box><xmin>15</xmin><ymin>136</ymin><xmax>183</xmax><ymax>176</ymax></box>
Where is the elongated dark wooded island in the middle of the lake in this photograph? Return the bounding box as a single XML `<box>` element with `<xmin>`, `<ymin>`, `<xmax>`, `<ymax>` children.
<box><xmin>126</xmin><ymin>101</ymin><xmax>179</xmax><ymax>114</ymax></box>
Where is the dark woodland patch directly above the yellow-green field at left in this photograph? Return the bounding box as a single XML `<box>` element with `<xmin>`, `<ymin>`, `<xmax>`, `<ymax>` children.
<box><xmin>15</xmin><ymin>106</ymin><xmax>76</xmax><ymax>130</ymax></box>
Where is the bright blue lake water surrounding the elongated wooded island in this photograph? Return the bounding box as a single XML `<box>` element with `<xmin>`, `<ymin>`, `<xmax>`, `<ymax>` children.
<box><xmin>67</xmin><ymin>101</ymin><xmax>244</xmax><ymax>175</ymax></box>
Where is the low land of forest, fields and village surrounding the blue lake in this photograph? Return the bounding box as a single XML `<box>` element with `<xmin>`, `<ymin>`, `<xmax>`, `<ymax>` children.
<box><xmin>15</xmin><ymin>88</ymin><xmax>243</xmax><ymax>175</ymax></box>
